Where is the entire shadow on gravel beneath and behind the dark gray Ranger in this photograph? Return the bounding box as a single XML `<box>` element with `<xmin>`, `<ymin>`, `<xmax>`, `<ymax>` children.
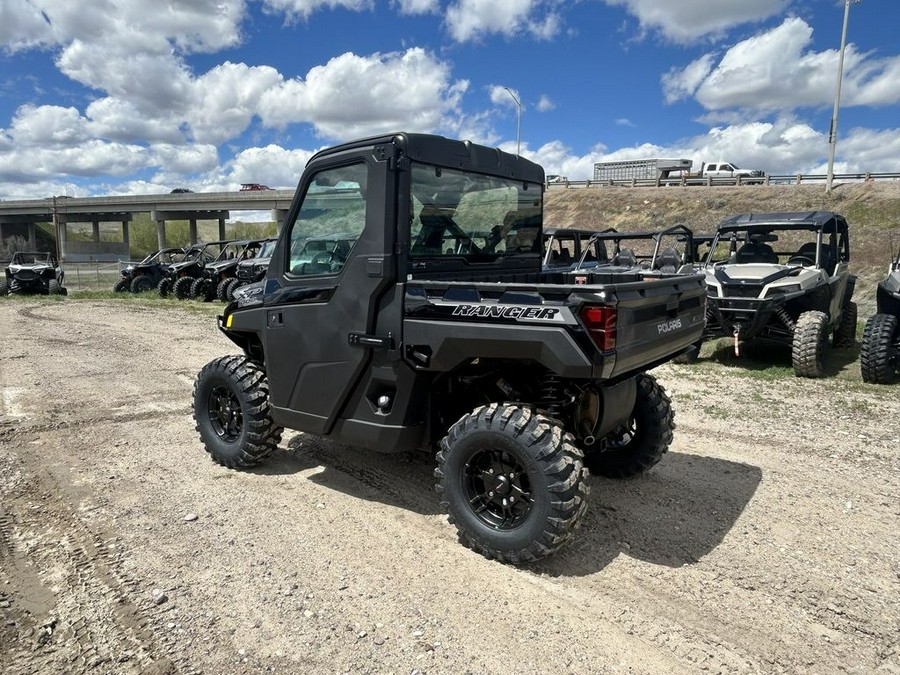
<box><xmin>252</xmin><ymin>435</ymin><xmax>762</xmax><ymax>576</ymax></box>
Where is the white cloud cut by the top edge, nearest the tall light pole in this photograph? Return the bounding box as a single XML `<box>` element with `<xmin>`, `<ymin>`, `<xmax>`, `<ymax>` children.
<box><xmin>604</xmin><ymin>0</ymin><xmax>790</xmax><ymax>44</ymax></box>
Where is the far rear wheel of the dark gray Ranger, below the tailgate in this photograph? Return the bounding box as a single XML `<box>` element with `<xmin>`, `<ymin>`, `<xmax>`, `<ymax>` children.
<box><xmin>584</xmin><ymin>373</ymin><xmax>675</xmax><ymax>478</ymax></box>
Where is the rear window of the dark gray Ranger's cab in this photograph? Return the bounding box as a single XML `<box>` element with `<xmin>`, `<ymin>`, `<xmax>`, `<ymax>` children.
<box><xmin>409</xmin><ymin>164</ymin><xmax>543</xmax><ymax>262</ymax></box>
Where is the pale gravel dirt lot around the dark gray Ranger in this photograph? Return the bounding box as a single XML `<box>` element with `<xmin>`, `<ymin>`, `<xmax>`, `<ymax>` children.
<box><xmin>0</xmin><ymin>297</ymin><xmax>900</xmax><ymax>674</ymax></box>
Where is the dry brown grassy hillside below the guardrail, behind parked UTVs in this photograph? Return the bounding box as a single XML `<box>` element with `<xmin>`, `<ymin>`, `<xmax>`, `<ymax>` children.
<box><xmin>544</xmin><ymin>182</ymin><xmax>900</xmax><ymax>318</ymax></box>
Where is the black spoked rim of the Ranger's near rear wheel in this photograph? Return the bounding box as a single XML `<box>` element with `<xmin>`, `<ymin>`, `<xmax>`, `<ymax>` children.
<box><xmin>463</xmin><ymin>450</ymin><xmax>533</xmax><ymax>530</ymax></box>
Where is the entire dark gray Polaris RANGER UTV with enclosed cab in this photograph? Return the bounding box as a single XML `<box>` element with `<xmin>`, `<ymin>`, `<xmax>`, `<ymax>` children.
<box><xmin>194</xmin><ymin>133</ymin><xmax>706</xmax><ymax>563</ymax></box>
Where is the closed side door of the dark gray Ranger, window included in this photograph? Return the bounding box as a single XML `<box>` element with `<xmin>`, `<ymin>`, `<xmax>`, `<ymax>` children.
<box><xmin>264</xmin><ymin>154</ymin><xmax>399</xmax><ymax>433</ymax></box>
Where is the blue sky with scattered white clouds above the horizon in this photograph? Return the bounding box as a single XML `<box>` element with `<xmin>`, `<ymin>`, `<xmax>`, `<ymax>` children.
<box><xmin>0</xmin><ymin>0</ymin><xmax>900</xmax><ymax>199</ymax></box>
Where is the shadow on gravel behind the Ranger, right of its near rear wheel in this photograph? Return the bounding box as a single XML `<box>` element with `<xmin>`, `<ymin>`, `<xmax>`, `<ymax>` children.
<box><xmin>533</xmin><ymin>453</ymin><xmax>762</xmax><ymax>576</ymax></box>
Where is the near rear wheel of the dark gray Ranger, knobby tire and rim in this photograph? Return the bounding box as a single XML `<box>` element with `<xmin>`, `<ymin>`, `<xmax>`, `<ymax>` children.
<box><xmin>434</xmin><ymin>403</ymin><xmax>588</xmax><ymax>564</ymax></box>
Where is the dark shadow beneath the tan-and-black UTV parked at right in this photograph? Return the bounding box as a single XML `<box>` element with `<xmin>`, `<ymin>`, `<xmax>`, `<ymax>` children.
<box><xmin>699</xmin><ymin>339</ymin><xmax>859</xmax><ymax>377</ymax></box>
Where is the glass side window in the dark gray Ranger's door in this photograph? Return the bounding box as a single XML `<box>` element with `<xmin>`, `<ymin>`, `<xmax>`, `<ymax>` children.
<box><xmin>287</xmin><ymin>163</ymin><xmax>367</xmax><ymax>277</ymax></box>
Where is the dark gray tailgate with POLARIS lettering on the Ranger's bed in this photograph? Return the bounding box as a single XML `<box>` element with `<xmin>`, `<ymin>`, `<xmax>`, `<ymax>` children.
<box><xmin>603</xmin><ymin>274</ymin><xmax>706</xmax><ymax>378</ymax></box>
